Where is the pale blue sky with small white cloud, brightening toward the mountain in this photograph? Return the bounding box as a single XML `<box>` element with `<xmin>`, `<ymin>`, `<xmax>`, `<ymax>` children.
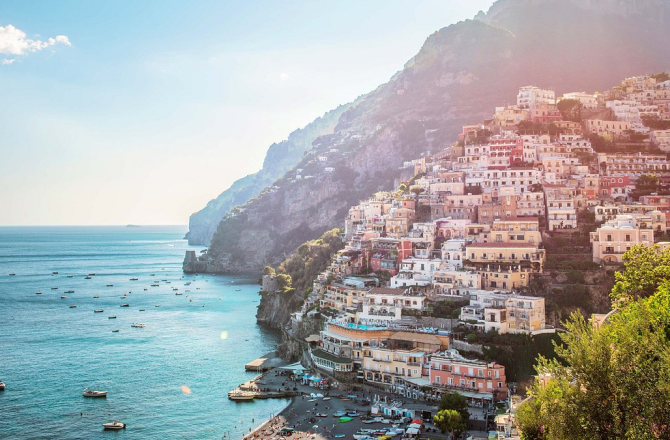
<box><xmin>0</xmin><ymin>0</ymin><xmax>493</xmax><ymax>225</ymax></box>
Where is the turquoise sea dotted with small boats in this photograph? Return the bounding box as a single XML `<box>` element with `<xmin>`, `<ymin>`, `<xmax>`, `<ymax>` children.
<box><xmin>0</xmin><ymin>226</ymin><xmax>288</xmax><ymax>439</ymax></box>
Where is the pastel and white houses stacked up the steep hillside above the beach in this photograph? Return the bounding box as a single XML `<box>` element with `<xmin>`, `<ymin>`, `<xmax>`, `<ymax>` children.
<box><xmin>263</xmin><ymin>75</ymin><xmax>670</xmax><ymax>438</ymax></box>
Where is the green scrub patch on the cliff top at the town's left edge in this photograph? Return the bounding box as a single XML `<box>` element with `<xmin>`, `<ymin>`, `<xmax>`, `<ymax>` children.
<box><xmin>277</xmin><ymin>229</ymin><xmax>344</xmax><ymax>292</ymax></box>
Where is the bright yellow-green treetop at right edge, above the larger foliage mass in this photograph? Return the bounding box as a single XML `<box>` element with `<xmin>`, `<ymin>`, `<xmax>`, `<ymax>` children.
<box><xmin>610</xmin><ymin>244</ymin><xmax>670</xmax><ymax>305</ymax></box>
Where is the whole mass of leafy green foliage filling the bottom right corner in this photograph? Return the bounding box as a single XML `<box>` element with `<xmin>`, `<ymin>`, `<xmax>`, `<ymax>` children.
<box><xmin>517</xmin><ymin>246</ymin><xmax>670</xmax><ymax>440</ymax></box>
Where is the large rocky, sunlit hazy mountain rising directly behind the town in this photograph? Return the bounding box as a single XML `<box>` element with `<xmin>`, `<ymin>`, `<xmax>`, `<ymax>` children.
<box><xmin>184</xmin><ymin>0</ymin><xmax>670</xmax><ymax>272</ymax></box>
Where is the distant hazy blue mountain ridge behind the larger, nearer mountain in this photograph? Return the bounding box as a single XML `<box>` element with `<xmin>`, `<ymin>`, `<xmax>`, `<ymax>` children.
<box><xmin>186</xmin><ymin>103</ymin><xmax>351</xmax><ymax>246</ymax></box>
